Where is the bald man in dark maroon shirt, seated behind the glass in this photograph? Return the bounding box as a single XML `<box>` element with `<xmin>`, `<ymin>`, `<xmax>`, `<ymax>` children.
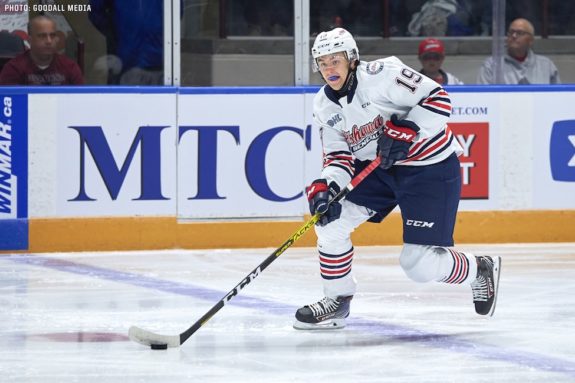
<box><xmin>0</xmin><ymin>16</ymin><xmax>84</xmax><ymax>85</ymax></box>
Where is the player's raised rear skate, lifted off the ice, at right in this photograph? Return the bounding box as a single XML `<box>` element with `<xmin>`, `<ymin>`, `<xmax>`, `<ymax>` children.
<box><xmin>471</xmin><ymin>257</ymin><xmax>501</xmax><ymax>316</ymax></box>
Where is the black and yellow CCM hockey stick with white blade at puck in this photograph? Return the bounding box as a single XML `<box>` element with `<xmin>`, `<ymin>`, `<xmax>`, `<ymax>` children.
<box><xmin>128</xmin><ymin>156</ymin><xmax>381</xmax><ymax>350</ymax></box>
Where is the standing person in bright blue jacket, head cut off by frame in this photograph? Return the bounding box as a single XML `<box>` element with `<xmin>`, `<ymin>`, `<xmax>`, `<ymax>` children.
<box><xmin>89</xmin><ymin>0</ymin><xmax>164</xmax><ymax>85</ymax></box>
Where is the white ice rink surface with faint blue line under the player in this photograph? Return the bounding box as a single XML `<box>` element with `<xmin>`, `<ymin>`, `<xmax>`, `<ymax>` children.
<box><xmin>0</xmin><ymin>244</ymin><xmax>575</xmax><ymax>383</ymax></box>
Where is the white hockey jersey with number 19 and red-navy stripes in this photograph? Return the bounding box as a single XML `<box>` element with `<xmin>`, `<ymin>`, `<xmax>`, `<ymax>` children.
<box><xmin>313</xmin><ymin>57</ymin><xmax>463</xmax><ymax>187</ymax></box>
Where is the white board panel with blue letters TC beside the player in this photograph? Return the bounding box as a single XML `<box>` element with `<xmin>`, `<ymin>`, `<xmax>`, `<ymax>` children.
<box><xmin>177</xmin><ymin>93</ymin><xmax>321</xmax><ymax>219</ymax></box>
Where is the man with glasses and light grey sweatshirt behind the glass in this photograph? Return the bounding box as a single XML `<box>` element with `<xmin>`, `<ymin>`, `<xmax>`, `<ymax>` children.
<box><xmin>477</xmin><ymin>19</ymin><xmax>561</xmax><ymax>84</ymax></box>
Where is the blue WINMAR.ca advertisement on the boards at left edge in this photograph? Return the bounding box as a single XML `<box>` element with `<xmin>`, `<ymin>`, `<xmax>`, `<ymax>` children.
<box><xmin>0</xmin><ymin>92</ymin><xmax>28</xmax><ymax>250</ymax></box>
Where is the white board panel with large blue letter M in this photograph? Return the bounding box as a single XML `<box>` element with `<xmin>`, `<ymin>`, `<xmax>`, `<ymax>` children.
<box><xmin>29</xmin><ymin>90</ymin><xmax>177</xmax><ymax>217</ymax></box>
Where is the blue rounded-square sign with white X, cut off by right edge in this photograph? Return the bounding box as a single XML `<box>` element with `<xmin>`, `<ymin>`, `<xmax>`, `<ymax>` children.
<box><xmin>549</xmin><ymin>120</ymin><xmax>575</xmax><ymax>182</ymax></box>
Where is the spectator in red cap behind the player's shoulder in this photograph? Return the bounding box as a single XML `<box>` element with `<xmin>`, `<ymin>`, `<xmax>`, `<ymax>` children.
<box><xmin>419</xmin><ymin>38</ymin><xmax>463</xmax><ymax>85</ymax></box>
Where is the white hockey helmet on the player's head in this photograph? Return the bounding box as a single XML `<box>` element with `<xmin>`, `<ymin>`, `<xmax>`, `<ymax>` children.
<box><xmin>311</xmin><ymin>28</ymin><xmax>359</xmax><ymax>72</ymax></box>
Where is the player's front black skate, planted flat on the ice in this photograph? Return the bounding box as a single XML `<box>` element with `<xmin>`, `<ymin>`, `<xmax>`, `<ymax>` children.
<box><xmin>293</xmin><ymin>295</ymin><xmax>353</xmax><ymax>330</ymax></box>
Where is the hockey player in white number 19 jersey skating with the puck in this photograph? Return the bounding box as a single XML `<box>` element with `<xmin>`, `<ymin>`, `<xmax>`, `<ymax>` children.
<box><xmin>294</xmin><ymin>28</ymin><xmax>501</xmax><ymax>329</ymax></box>
